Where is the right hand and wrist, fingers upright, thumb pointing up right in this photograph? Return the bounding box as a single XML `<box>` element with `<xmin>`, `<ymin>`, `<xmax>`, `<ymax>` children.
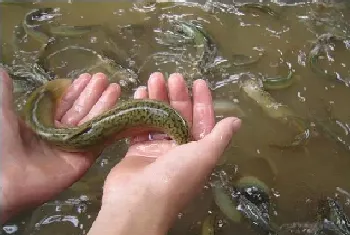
<box><xmin>89</xmin><ymin>73</ymin><xmax>241</xmax><ymax>235</ymax></box>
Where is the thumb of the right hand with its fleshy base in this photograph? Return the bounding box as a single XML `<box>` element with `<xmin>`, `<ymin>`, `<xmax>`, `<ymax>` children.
<box><xmin>153</xmin><ymin>117</ymin><xmax>241</xmax><ymax>180</ymax></box>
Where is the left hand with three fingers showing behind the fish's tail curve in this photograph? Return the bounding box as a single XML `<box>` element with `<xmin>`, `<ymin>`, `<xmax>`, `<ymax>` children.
<box><xmin>0</xmin><ymin>69</ymin><xmax>120</xmax><ymax>223</ymax></box>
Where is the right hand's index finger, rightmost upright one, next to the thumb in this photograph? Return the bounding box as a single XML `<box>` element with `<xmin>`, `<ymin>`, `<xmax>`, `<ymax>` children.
<box><xmin>192</xmin><ymin>79</ymin><xmax>215</xmax><ymax>140</ymax></box>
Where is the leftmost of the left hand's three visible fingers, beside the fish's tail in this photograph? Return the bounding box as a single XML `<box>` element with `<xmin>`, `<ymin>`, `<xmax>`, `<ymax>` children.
<box><xmin>55</xmin><ymin>73</ymin><xmax>91</xmax><ymax>120</ymax></box>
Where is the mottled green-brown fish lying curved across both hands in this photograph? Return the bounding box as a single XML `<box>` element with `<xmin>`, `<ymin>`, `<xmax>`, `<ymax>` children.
<box><xmin>23</xmin><ymin>79</ymin><xmax>190</xmax><ymax>152</ymax></box>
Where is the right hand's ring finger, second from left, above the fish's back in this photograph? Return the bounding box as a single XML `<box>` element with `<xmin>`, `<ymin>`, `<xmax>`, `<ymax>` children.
<box><xmin>148</xmin><ymin>72</ymin><xmax>169</xmax><ymax>102</ymax></box>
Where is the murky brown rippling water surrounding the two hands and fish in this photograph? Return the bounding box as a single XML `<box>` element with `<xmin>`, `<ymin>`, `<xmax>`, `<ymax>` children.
<box><xmin>0</xmin><ymin>1</ymin><xmax>350</xmax><ymax>235</ymax></box>
